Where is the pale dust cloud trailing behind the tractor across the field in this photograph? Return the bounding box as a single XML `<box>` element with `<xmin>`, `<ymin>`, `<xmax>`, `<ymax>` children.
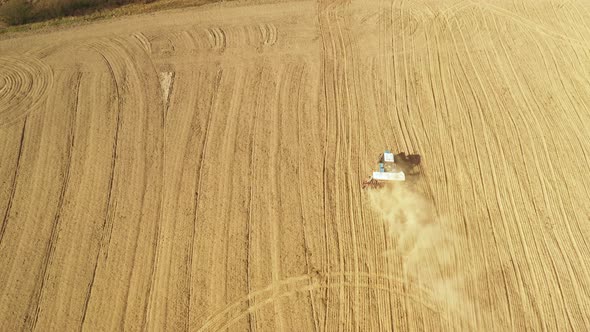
<box><xmin>369</xmin><ymin>184</ymin><xmax>477</xmax><ymax>328</ymax></box>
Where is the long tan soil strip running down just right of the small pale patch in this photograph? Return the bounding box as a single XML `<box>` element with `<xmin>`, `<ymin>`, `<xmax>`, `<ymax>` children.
<box><xmin>146</xmin><ymin>66</ymin><xmax>226</xmax><ymax>330</ymax></box>
